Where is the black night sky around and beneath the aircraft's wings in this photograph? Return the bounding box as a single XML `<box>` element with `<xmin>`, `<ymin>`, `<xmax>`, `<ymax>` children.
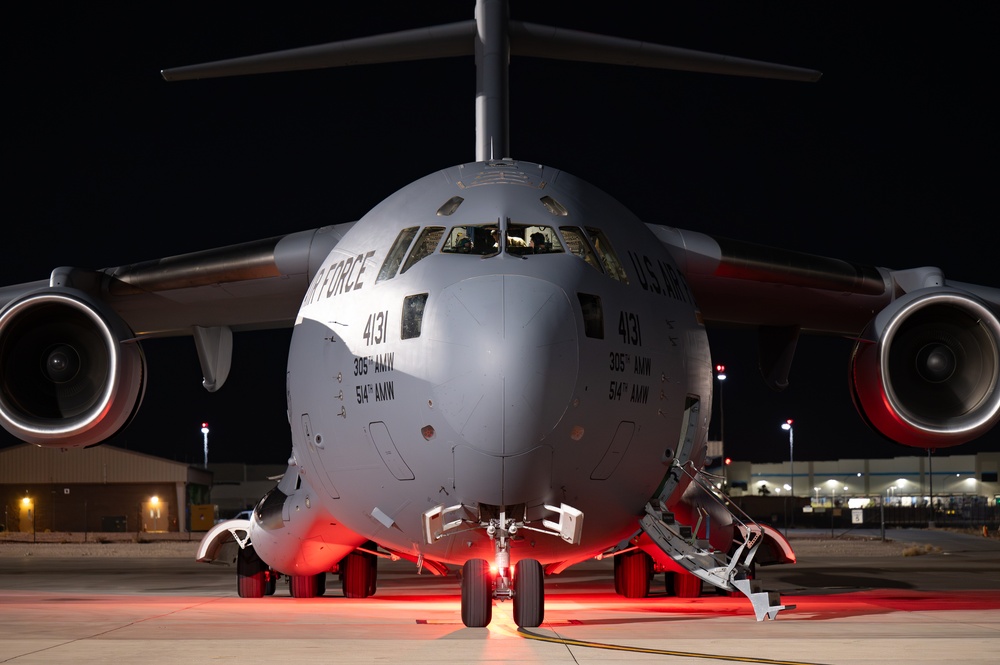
<box><xmin>0</xmin><ymin>0</ymin><xmax>1000</xmax><ymax>463</ymax></box>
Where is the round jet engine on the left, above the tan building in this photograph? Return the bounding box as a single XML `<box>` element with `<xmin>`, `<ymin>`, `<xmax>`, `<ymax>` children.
<box><xmin>0</xmin><ymin>288</ymin><xmax>146</xmax><ymax>448</ymax></box>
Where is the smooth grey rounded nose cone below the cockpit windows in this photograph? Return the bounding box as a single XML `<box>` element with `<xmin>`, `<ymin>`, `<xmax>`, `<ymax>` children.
<box><xmin>427</xmin><ymin>275</ymin><xmax>579</xmax><ymax>456</ymax></box>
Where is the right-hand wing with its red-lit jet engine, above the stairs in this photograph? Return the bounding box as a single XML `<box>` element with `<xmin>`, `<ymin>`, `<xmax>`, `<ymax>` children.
<box><xmin>649</xmin><ymin>225</ymin><xmax>1000</xmax><ymax>448</ymax></box>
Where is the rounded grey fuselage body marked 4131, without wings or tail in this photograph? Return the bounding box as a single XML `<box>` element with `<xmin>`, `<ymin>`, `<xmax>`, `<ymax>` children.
<box><xmin>253</xmin><ymin>160</ymin><xmax>712</xmax><ymax>574</ymax></box>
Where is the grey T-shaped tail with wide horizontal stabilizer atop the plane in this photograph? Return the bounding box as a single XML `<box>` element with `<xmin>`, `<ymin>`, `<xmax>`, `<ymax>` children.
<box><xmin>161</xmin><ymin>0</ymin><xmax>822</xmax><ymax>161</ymax></box>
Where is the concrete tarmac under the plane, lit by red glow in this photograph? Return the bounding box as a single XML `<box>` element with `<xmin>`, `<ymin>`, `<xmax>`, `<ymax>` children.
<box><xmin>0</xmin><ymin>530</ymin><xmax>1000</xmax><ymax>665</ymax></box>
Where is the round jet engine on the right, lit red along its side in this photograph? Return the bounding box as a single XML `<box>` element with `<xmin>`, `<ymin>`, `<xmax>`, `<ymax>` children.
<box><xmin>851</xmin><ymin>288</ymin><xmax>1000</xmax><ymax>448</ymax></box>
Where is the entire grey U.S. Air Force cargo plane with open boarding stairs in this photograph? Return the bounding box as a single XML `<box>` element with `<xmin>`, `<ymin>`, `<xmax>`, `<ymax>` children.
<box><xmin>0</xmin><ymin>0</ymin><xmax>1000</xmax><ymax>627</ymax></box>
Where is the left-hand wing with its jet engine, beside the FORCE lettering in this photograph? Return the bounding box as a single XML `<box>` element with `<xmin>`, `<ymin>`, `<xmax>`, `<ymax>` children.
<box><xmin>0</xmin><ymin>223</ymin><xmax>353</xmax><ymax>448</ymax></box>
